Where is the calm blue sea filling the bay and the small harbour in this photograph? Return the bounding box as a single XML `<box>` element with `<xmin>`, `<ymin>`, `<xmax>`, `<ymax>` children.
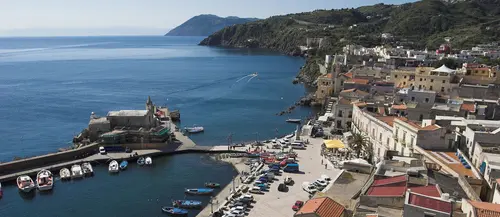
<box><xmin>0</xmin><ymin>36</ymin><xmax>312</xmax><ymax>217</ymax></box>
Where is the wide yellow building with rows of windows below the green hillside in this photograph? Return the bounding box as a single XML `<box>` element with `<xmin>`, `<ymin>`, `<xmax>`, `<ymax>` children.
<box><xmin>391</xmin><ymin>65</ymin><xmax>459</xmax><ymax>95</ymax></box>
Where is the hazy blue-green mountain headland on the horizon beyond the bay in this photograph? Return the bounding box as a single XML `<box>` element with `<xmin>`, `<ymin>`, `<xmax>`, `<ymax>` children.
<box><xmin>165</xmin><ymin>14</ymin><xmax>259</xmax><ymax>36</ymax></box>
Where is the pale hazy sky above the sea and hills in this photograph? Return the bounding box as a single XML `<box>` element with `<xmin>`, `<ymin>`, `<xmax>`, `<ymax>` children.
<box><xmin>0</xmin><ymin>0</ymin><xmax>415</xmax><ymax>36</ymax></box>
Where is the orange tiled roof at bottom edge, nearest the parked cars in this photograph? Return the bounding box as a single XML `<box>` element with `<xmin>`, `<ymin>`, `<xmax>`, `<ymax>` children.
<box><xmin>295</xmin><ymin>197</ymin><xmax>345</xmax><ymax>217</ymax></box>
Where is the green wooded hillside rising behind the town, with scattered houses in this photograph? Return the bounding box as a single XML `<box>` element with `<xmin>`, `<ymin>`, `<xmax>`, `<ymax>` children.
<box><xmin>200</xmin><ymin>0</ymin><xmax>500</xmax><ymax>83</ymax></box>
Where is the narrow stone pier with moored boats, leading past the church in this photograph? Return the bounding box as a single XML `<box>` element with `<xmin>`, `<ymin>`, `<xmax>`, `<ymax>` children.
<box><xmin>0</xmin><ymin>132</ymin><xmax>244</xmax><ymax>182</ymax></box>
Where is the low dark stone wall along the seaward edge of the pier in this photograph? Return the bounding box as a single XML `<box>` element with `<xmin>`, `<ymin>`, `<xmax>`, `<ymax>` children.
<box><xmin>0</xmin><ymin>143</ymin><xmax>99</xmax><ymax>175</ymax></box>
